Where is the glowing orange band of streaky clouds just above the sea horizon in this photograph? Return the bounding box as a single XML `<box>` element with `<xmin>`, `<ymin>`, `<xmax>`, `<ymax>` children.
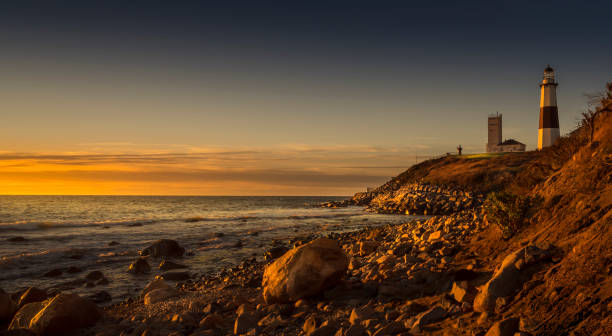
<box><xmin>0</xmin><ymin>144</ymin><xmax>426</xmax><ymax>195</ymax></box>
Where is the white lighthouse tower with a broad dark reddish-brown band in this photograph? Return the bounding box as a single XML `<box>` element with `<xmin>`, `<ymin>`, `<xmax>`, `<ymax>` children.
<box><xmin>538</xmin><ymin>65</ymin><xmax>559</xmax><ymax>149</ymax></box>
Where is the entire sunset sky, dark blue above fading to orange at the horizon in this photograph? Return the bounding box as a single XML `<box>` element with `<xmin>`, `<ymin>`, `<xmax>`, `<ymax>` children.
<box><xmin>0</xmin><ymin>0</ymin><xmax>612</xmax><ymax>195</ymax></box>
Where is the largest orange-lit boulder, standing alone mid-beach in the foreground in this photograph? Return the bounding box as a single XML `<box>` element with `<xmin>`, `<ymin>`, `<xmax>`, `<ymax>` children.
<box><xmin>262</xmin><ymin>238</ymin><xmax>348</xmax><ymax>303</ymax></box>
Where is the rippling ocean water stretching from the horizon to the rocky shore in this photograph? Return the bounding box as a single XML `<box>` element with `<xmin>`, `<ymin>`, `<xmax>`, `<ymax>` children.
<box><xmin>0</xmin><ymin>196</ymin><xmax>412</xmax><ymax>302</ymax></box>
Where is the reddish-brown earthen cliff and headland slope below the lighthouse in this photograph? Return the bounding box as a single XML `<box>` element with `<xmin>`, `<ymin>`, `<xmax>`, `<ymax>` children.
<box><xmin>342</xmin><ymin>85</ymin><xmax>612</xmax><ymax>335</ymax></box>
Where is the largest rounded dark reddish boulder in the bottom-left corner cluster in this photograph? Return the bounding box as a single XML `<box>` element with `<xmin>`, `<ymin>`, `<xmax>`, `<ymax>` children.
<box><xmin>29</xmin><ymin>293</ymin><xmax>102</xmax><ymax>335</ymax></box>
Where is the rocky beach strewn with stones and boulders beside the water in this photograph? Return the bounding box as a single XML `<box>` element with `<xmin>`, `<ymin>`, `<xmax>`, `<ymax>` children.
<box><xmin>4</xmin><ymin>186</ymin><xmax>546</xmax><ymax>336</ymax></box>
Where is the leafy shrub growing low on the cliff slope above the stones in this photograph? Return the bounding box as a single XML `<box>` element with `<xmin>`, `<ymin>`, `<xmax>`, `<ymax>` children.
<box><xmin>484</xmin><ymin>191</ymin><xmax>541</xmax><ymax>239</ymax></box>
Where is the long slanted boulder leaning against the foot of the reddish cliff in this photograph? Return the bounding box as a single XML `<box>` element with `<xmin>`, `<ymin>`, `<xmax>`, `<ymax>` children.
<box><xmin>474</xmin><ymin>245</ymin><xmax>548</xmax><ymax>312</ymax></box>
